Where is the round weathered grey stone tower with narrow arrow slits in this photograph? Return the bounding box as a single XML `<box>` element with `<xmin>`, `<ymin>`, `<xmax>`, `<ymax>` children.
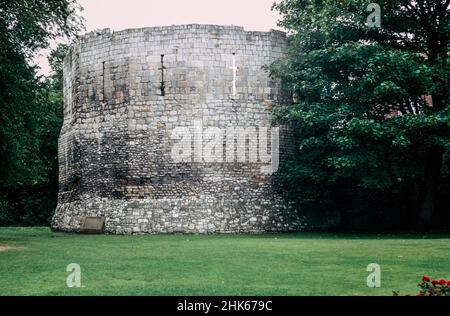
<box><xmin>52</xmin><ymin>25</ymin><xmax>301</xmax><ymax>234</ymax></box>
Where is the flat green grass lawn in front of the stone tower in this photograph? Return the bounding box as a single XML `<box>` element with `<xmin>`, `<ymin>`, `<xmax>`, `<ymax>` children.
<box><xmin>0</xmin><ymin>228</ymin><xmax>450</xmax><ymax>295</ymax></box>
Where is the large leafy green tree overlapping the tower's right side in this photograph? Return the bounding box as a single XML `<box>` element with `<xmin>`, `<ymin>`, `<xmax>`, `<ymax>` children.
<box><xmin>270</xmin><ymin>0</ymin><xmax>450</xmax><ymax>227</ymax></box>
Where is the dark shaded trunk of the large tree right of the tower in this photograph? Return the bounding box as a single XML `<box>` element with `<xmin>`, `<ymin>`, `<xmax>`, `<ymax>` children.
<box><xmin>419</xmin><ymin>147</ymin><xmax>444</xmax><ymax>228</ymax></box>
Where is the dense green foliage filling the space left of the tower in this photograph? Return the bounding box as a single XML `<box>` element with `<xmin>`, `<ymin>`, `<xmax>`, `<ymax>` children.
<box><xmin>0</xmin><ymin>0</ymin><xmax>81</xmax><ymax>225</ymax></box>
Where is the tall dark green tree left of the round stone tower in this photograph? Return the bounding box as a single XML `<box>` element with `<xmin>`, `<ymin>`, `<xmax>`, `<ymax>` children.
<box><xmin>0</xmin><ymin>0</ymin><xmax>82</xmax><ymax>223</ymax></box>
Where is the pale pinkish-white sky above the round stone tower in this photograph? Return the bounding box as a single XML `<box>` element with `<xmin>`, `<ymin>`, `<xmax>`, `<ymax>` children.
<box><xmin>36</xmin><ymin>0</ymin><xmax>280</xmax><ymax>74</ymax></box>
